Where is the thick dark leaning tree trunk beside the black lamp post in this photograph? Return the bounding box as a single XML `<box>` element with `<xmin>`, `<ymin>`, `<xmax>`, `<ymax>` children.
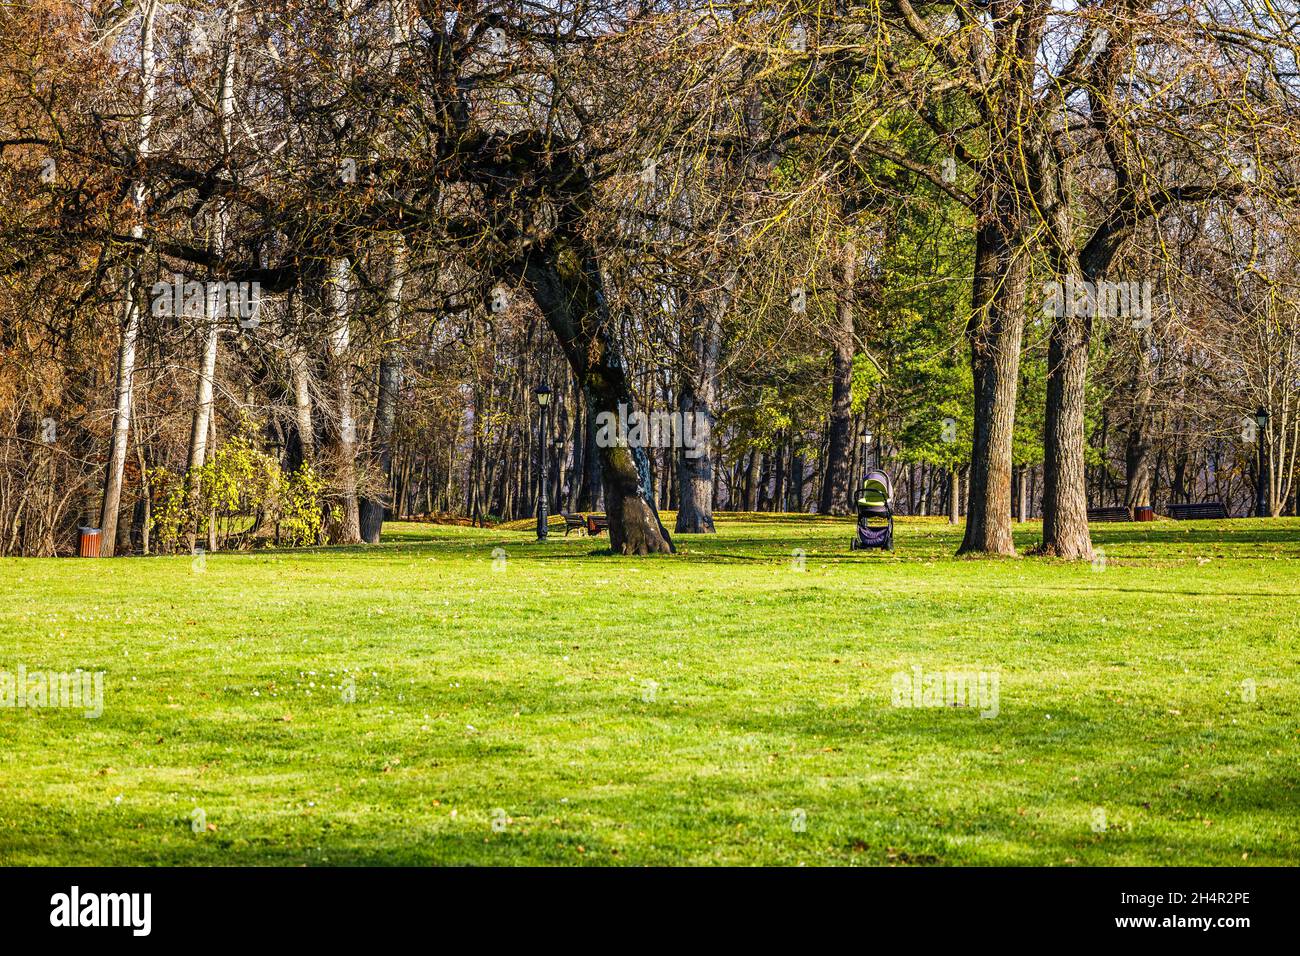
<box><xmin>524</xmin><ymin>234</ymin><xmax>673</xmax><ymax>554</ymax></box>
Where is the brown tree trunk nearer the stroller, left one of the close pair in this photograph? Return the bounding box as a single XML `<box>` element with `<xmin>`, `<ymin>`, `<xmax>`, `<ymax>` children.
<box><xmin>958</xmin><ymin>214</ymin><xmax>1028</xmax><ymax>555</ymax></box>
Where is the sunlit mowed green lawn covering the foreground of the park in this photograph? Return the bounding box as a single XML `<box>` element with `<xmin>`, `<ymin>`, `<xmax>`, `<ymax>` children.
<box><xmin>0</xmin><ymin>515</ymin><xmax>1300</xmax><ymax>866</ymax></box>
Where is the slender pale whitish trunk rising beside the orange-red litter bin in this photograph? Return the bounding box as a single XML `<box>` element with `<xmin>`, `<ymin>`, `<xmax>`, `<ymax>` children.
<box><xmin>99</xmin><ymin>0</ymin><xmax>157</xmax><ymax>558</ymax></box>
